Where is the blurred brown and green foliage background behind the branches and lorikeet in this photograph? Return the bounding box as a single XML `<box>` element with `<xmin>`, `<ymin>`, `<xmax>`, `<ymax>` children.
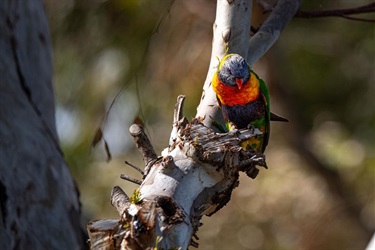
<box><xmin>45</xmin><ymin>0</ymin><xmax>375</xmax><ymax>249</ymax></box>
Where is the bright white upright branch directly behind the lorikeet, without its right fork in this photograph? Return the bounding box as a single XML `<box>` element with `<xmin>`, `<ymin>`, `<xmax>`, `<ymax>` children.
<box><xmin>195</xmin><ymin>0</ymin><xmax>252</xmax><ymax>129</ymax></box>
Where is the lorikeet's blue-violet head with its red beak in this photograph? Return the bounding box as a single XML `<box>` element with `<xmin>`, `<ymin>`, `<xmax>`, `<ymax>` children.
<box><xmin>218</xmin><ymin>54</ymin><xmax>250</xmax><ymax>89</ymax></box>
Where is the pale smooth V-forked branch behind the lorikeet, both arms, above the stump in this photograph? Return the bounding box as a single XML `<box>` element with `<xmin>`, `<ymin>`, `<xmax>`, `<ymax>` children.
<box><xmin>195</xmin><ymin>0</ymin><xmax>302</xmax><ymax>129</ymax></box>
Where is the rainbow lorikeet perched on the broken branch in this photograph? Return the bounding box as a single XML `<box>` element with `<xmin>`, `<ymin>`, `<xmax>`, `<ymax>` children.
<box><xmin>212</xmin><ymin>54</ymin><xmax>287</xmax><ymax>153</ymax></box>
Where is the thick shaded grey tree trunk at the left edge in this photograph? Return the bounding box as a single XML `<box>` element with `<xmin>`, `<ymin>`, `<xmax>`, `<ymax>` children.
<box><xmin>0</xmin><ymin>0</ymin><xmax>84</xmax><ymax>249</ymax></box>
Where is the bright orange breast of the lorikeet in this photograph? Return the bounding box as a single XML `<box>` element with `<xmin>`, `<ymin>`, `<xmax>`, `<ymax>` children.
<box><xmin>212</xmin><ymin>73</ymin><xmax>260</xmax><ymax>106</ymax></box>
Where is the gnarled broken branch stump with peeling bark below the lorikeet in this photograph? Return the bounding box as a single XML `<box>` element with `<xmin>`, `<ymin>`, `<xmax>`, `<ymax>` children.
<box><xmin>87</xmin><ymin>96</ymin><xmax>266</xmax><ymax>249</ymax></box>
